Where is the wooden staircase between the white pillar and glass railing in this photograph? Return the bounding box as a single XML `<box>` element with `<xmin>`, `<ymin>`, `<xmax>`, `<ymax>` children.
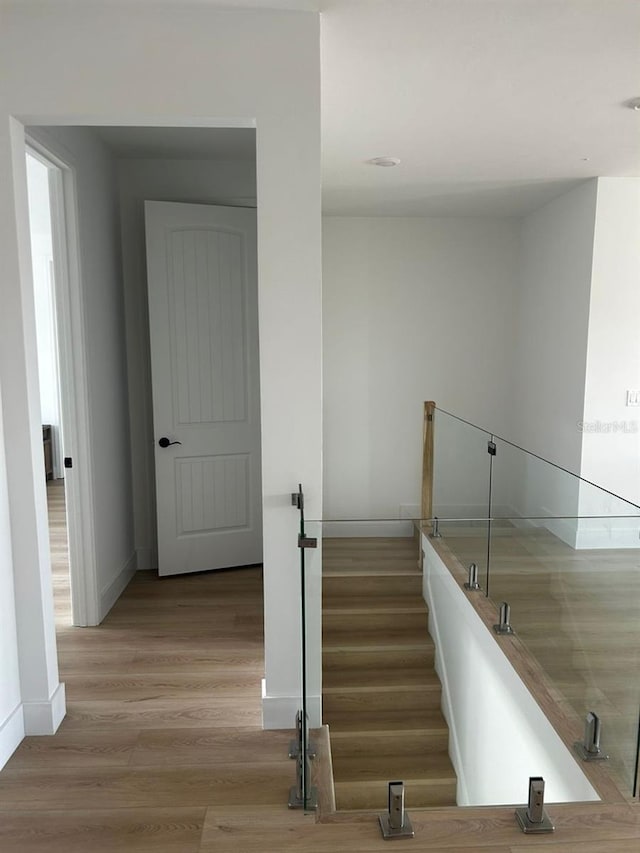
<box><xmin>322</xmin><ymin>538</ymin><xmax>456</xmax><ymax>810</ymax></box>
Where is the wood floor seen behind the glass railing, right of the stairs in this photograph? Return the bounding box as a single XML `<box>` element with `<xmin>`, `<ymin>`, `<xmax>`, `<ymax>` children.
<box><xmin>442</xmin><ymin>523</ymin><xmax>640</xmax><ymax>793</ymax></box>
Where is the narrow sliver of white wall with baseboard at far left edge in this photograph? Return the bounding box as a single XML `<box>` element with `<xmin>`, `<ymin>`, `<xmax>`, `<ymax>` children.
<box><xmin>0</xmin><ymin>382</ymin><xmax>24</xmax><ymax>768</ymax></box>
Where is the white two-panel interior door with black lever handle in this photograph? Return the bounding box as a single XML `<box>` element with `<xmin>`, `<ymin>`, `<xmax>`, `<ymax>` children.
<box><xmin>145</xmin><ymin>202</ymin><xmax>262</xmax><ymax>575</ymax></box>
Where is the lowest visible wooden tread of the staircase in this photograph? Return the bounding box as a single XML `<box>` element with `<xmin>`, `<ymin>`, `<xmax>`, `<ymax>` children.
<box><xmin>333</xmin><ymin>752</ymin><xmax>456</xmax><ymax>790</ymax></box>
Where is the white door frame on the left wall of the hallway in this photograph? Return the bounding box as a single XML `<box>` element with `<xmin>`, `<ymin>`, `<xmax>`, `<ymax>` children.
<box><xmin>25</xmin><ymin>132</ymin><xmax>100</xmax><ymax>626</ymax></box>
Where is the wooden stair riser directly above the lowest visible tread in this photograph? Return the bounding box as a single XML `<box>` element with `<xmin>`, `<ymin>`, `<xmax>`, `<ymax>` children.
<box><xmin>330</xmin><ymin>726</ymin><xmax>449</xmax><ymax>764</ymax></box>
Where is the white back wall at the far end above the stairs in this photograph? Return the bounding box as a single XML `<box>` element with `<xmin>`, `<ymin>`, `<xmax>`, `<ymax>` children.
<box><xmin>323</xmin><ymin>217</ymin><xmax>518</xmax><ymax>518</ymax></box>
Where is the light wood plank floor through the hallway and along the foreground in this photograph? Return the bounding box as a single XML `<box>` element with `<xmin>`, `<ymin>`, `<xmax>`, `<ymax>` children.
<box><xmin>0</xmin><ymin>486</ymin><xmax>640</xmax><ymax>853</ymax></box>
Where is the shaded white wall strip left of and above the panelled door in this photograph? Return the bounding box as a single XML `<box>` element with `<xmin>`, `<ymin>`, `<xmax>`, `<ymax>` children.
<box><xmin>118</xmin><ymin>158</ymin><xmax>256</xmax><ymax>569</ymax></box>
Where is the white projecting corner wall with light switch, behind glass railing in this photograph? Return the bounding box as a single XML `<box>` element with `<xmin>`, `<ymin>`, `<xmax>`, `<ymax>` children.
<box><xmin>504</xmin><ymin>178</ymin><xmax>640</xmax><ymax>548</ymax></box>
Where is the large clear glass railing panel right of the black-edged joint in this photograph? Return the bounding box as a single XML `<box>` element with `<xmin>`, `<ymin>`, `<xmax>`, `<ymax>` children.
<box><xmin>488</xmin><ymin>439</ymin><xmax>640</xmax><ymax>793</ymax></box>
